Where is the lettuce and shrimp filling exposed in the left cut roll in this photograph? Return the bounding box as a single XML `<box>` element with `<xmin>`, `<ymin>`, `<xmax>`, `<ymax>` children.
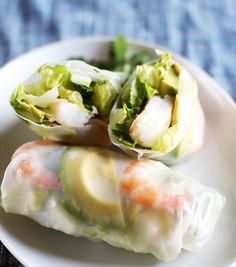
<box><xmin>10</xmin><ymin>61</ymin><xmax>122</xmax><ymax>127</ymax></box>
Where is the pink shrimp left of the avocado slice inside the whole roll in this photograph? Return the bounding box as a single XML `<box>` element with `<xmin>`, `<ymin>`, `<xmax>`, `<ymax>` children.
<box><xmin>18</xmin><ymin>157</ymin><xmax>61</xmax><ymax>190</ymax></box>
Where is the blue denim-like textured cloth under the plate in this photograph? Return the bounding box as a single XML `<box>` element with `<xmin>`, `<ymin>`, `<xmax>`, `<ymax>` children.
<box><xmin>0</xmin><ymin>0</ymin><xmax>236</xmax><ymax>266</ymax></box>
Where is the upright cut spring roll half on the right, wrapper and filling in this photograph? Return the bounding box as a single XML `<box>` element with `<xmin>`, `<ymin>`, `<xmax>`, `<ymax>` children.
<box><xmin>109</xmin><ymin>53</ymin><xmax>204</xmax><ymax>164</ymax></box>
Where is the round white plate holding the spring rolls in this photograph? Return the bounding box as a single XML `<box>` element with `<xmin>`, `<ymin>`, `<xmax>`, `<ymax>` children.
<box><xmin>0</xmin><ymin>38</ymin><xmax>236</xmax><ymax>267</ymax></box>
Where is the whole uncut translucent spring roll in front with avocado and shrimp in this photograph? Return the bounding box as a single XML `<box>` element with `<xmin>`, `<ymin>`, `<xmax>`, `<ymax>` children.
<box><xmin>1</xmin><ymin>141</ymin><xmax>225</xmax><ymax>261</ymax></box>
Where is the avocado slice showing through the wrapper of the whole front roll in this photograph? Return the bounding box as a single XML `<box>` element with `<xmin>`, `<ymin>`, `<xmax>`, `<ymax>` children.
<box><xmin>60</xmin><ymin>147</ymin><xmax>125</xmax><ymax>226</ymax></box>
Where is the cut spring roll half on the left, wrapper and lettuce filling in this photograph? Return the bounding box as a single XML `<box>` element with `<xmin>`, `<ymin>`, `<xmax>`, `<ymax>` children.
<box><xmin>10</xmin><ymin>60</ymin><xmax>123</xmax><ymax>145</ymax></box>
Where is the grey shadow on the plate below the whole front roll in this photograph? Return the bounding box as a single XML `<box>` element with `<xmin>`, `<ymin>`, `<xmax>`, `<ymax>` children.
<box><xmin>0</xmin><ymin>211</ymin><xmax>157</xmax><ymax>266</ymax></box>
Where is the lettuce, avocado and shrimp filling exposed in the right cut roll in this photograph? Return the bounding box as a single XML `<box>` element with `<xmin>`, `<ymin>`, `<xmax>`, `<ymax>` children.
<box><xmin>111</xmin><ymin>53</ymin><xmax>184</xmax><ymax>149</ymax></box>
